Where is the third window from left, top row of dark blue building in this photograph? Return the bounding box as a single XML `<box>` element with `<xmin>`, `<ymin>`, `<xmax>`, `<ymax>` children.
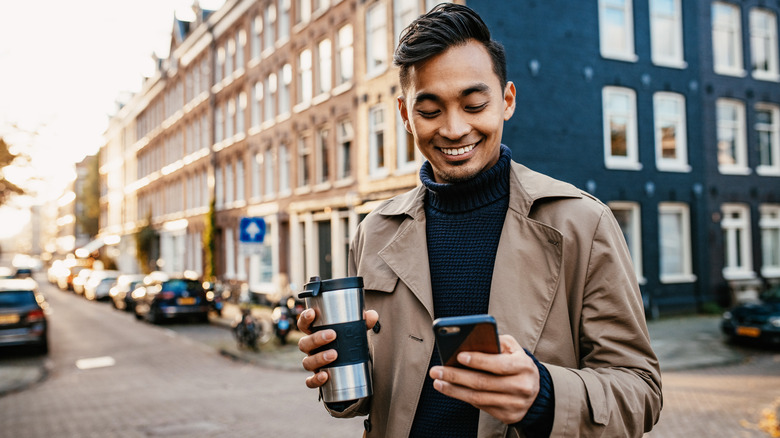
<box><xmin>712</xmin><ymin>2</ymin><xmax>745</xmax><ymax>76</ymax></box>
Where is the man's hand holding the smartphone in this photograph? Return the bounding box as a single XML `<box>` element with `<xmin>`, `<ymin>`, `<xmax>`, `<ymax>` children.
<box><xmin>430</xmin><ymin>335</ymin><xmax>539</xmax><ymax>424</ymax></box>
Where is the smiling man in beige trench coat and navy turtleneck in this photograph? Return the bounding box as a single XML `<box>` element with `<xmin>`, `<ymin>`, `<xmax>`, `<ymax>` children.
<box><xmin>299</xmin><ymin>4</ymin><xmax>661</xmax><ymax>437</ymax></box>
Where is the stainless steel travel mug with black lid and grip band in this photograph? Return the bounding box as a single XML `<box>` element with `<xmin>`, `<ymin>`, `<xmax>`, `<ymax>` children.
<box><xmin>298</xmin><ymin>277</ymin><xmax>372</xmax><ymax>403</ymax></box>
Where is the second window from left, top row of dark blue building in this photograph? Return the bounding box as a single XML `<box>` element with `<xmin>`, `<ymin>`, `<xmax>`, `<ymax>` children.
<box><xmin>650</xmin><ymin>0</ymin><xmax>685</xmax><ymax>68</ymax></box>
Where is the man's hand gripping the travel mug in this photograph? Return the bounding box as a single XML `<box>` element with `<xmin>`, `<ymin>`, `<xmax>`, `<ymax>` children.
<box><xmin>298</xmin><ymin>309</ymin><xmax>379</xmax><ymax>388</ymax></box>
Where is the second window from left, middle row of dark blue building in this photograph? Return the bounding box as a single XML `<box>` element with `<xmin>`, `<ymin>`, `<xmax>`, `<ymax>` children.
<box><xmin>653</xmin><ymin>92</ymin><xmax>691</xmax><ymax>172</ymax></box>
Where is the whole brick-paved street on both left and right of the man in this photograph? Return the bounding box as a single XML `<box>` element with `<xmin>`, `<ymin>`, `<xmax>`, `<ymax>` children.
<box><xmin>0</xmin><ymin>278</ymin><xmax>780</xmax><ymax>438</ymax></box>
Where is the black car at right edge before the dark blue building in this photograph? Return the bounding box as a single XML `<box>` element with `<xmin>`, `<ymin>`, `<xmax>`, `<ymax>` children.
<box><xmin>720</xmin><ymin>286</ymin><xmax>780</xmax><ymax>345</ymax></box>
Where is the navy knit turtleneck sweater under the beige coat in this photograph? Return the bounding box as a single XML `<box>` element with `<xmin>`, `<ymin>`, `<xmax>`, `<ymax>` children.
<box><xmin>409</xmin><ymin>145</ymin><xmax>554</xmax><ymax>438</ymax></box>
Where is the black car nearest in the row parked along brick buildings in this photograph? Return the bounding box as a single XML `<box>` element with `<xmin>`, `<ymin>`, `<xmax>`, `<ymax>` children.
<box><xmin>132</xmin><ymin>274</ymin><xmax>209</xmax><ymax>324</ymax></box>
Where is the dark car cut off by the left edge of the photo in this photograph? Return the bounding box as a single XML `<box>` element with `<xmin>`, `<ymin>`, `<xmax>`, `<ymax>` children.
<box><xmin>0</xmin><ymin>278</ymin><xmax>49</xmax><ymax>353</ymax></box>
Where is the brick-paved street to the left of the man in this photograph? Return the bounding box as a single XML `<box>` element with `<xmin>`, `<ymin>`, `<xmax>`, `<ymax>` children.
<box><xmin>0</xmin><ymin>278</ymin><xmax>363</xmax><ymax>438</ymax></box>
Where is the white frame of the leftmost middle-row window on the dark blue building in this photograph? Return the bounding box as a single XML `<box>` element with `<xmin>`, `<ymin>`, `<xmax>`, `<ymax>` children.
<box><xmin>602</xmin><ymin>86</ymin><xmax>642</xmax><ymax>170</ymax></box>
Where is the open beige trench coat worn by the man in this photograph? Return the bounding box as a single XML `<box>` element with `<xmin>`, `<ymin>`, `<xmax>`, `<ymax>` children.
<box><xmin>331</xmin><ymin>162</ymin><xmax>662</xmax><ymax>438</ymax></box>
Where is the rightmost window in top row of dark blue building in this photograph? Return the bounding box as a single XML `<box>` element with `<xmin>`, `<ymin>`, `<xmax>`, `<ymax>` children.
<box><xmin>750</xmin><ymin>8</ymin><xmax>780</xmax><ymax>81</ymax></box>
